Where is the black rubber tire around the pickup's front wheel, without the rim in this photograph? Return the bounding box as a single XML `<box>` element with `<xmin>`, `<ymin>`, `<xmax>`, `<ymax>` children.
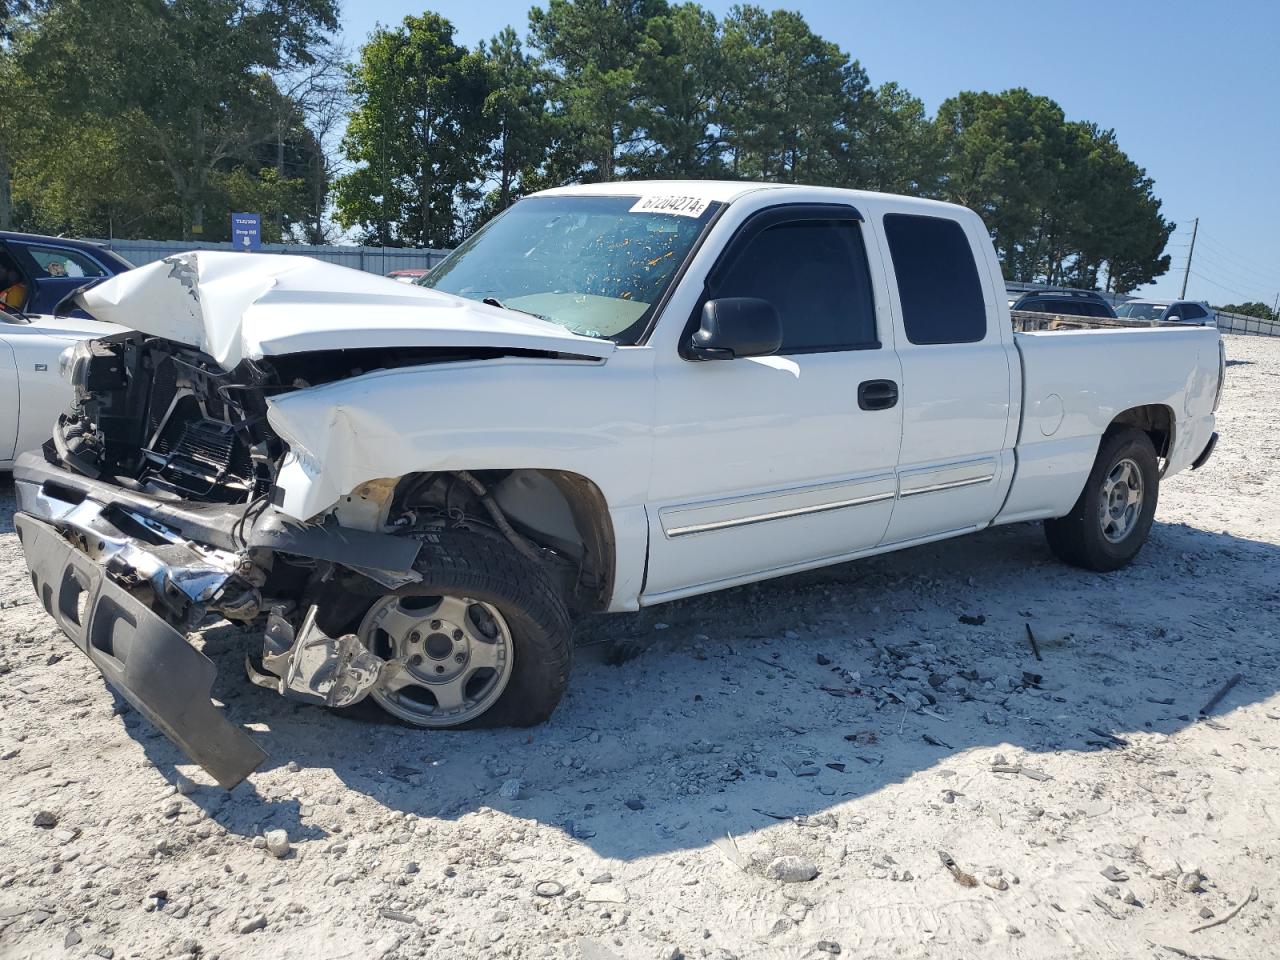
<box><xmin>348</xmin><ymin>530</ymin><xmax>573</xmax><ymax>730</ymax></box>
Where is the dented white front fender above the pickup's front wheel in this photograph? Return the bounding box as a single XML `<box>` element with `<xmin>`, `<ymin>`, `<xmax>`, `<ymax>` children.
<box><xmin>268</xmin><ymin>351</ymin><xmax>653</xmax><ymax>520</ymax></box>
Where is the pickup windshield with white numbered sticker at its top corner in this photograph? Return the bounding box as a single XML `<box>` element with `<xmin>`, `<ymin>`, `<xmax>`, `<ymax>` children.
<box><xmin>419</xmin><ymin>197</ymin><xmax>719</xmax><ymax>346</ymax></box>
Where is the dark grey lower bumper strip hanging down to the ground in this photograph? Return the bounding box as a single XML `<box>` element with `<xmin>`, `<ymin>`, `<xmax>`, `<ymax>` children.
<box><xmin>14</xmin><ymin>513</ymin><xmax>266</xmax><ymax>790</ymax></box>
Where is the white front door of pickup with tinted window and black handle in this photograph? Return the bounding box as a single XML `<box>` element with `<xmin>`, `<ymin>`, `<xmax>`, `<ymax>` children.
<box><xmin>641</xmin><ymin>204</ymin><xmax>902</xmax><ymax>603</ymax></box>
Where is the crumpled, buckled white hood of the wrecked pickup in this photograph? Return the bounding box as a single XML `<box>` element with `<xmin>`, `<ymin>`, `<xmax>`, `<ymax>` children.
<box><xmin>77</xmin><ymin>251</ymin><xmax>614</xmax><ymax>370</ymax></box>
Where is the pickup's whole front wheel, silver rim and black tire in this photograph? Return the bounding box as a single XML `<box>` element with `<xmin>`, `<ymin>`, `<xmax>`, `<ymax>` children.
<box><xmin>355</xmin><ymin>531</ymin><xmax>572</xmax><ymax>727</ymax></box>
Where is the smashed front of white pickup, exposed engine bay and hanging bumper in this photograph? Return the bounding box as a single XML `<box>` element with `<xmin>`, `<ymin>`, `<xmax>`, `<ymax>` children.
<box><xmin>15</xmin><ymin>334</ymin><xmax>432</xmax><ymax>787</ymax></box>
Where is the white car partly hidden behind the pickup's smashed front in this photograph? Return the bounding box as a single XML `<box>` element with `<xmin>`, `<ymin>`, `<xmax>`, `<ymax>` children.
<box><xmin>0</xmin><ymin>310</ymin><xmax>122</xmax><ymax>472</ymax></box>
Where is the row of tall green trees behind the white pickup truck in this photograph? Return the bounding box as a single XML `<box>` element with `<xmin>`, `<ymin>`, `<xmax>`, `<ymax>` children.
<box><xmin>0</xmin><ymin>0</ymin><xmax>1174</xmax><ymax>293</ymax></box>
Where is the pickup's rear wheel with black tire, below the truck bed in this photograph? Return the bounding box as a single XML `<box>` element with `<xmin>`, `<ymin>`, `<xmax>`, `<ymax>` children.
<box><xmin>1044</xmin><ymin>426</ymin><xmax>1160</xmax><ymax>572</ymax></box>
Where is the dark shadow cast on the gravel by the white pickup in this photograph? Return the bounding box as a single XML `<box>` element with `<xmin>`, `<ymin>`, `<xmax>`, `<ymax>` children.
<box><xmin>97</xmin><ymin>506</ymin><xmax>1280</xmax><ymax>859</ymax></box>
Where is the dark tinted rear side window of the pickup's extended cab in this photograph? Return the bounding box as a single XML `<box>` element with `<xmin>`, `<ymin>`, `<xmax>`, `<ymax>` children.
<box><xmin>884</xmin><ymin>214</ymin><xmax>987</xmax><ymax>344</ymax></box>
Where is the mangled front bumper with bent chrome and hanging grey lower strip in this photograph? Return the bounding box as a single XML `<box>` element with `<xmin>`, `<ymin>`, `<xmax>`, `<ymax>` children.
<box><xmin>14</xmin><ymin>453</ymin><xmax>421</xmax><ymax>788</ymax></box>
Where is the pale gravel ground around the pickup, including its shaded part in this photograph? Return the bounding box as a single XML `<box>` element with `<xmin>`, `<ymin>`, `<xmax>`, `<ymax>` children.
<box><xmin>0</xmin><ymin>338</ymin><xmax>1280</xmax><ymax>960</ymax></box>
